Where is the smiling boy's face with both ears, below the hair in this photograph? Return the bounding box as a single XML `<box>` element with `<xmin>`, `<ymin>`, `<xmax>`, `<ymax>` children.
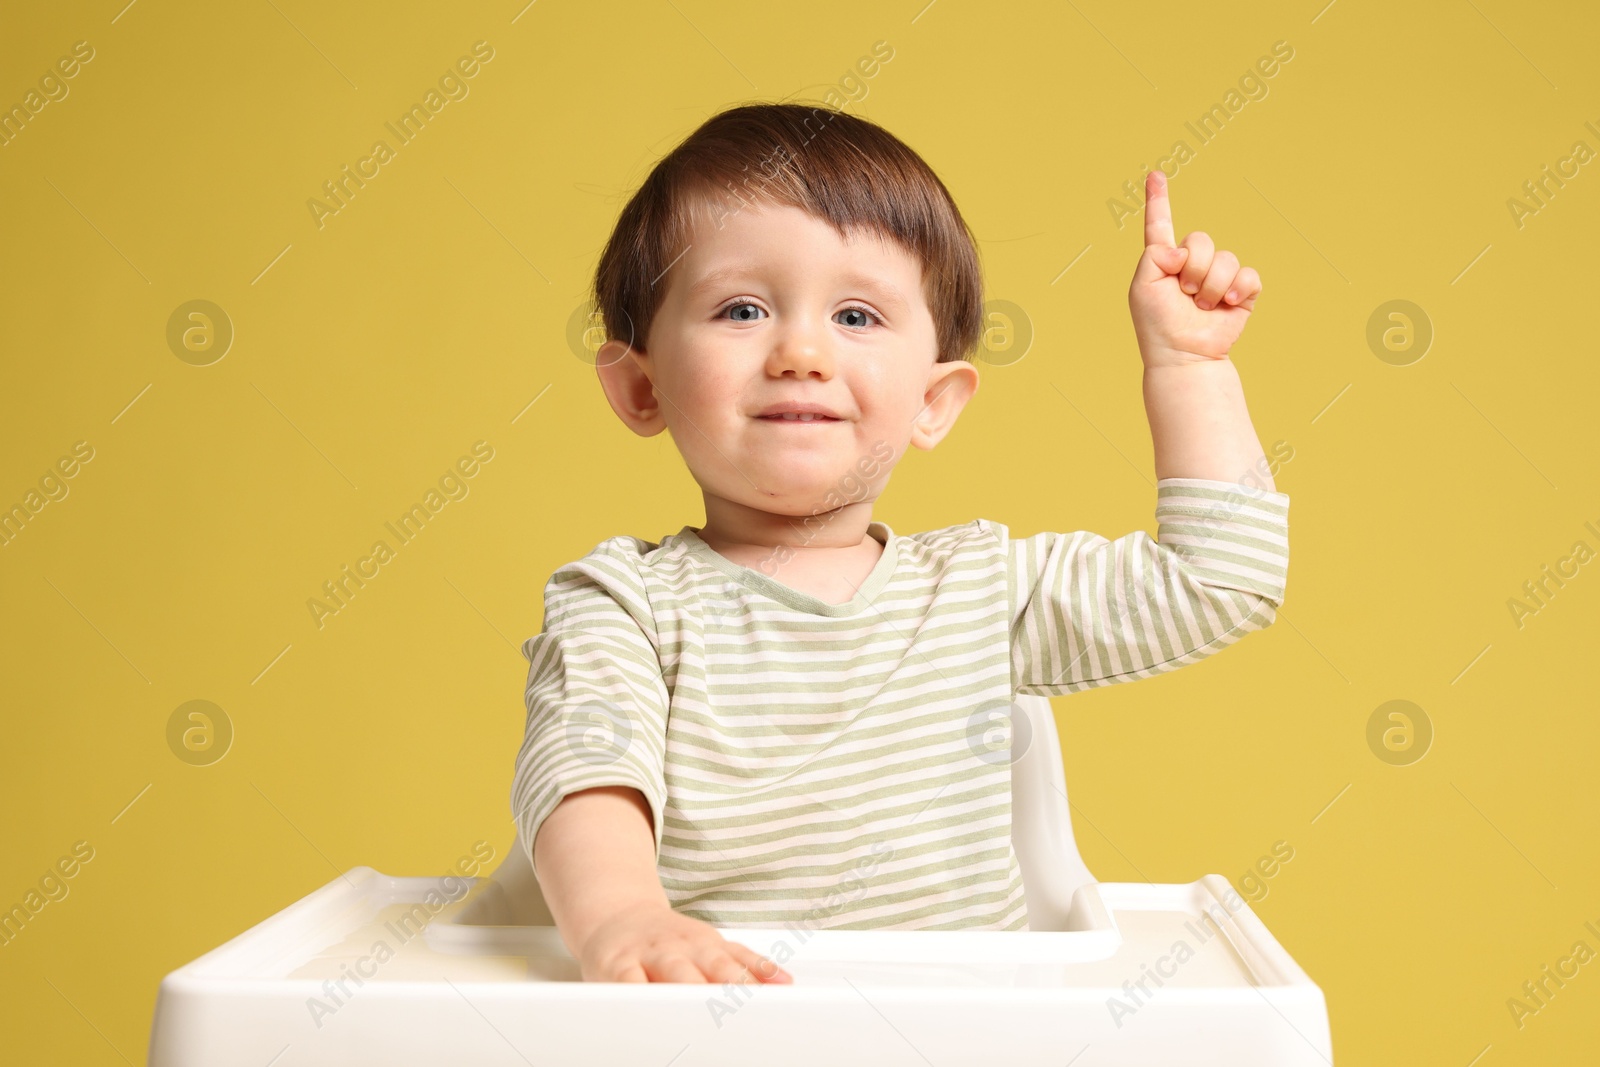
<box><xmin>597</xmin><ymin>203</ymin><xmax>978</xmax><ymax>515</ymax></box>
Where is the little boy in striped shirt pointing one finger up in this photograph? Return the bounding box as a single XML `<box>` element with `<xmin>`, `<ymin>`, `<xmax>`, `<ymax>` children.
<box><xmin>512</xmin><ymin>104</ymin><xmax>1288</xmax><ymax>984</ymax></box>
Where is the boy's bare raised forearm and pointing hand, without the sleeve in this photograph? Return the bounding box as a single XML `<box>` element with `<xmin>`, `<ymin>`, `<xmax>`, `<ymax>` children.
<box><xmin>1128</xmin><ymin>170</ymin><xmax>1274</xmax><ymax>491</ymax></box>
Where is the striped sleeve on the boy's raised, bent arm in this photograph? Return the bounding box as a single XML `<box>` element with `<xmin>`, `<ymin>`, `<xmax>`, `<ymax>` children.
<box><xmin>989</xmin><ymin>478</ymin><xmax>1290</xmax><ymax>696</ymax></box>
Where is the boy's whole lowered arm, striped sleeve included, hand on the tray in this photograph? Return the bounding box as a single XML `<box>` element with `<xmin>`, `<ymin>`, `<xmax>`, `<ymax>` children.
<box><xmin>510</xmin><ymin>537</ymin><xmax>790</xmax><ymax>982</ymax></box>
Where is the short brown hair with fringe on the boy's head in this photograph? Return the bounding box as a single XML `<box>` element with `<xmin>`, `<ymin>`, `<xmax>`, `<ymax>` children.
<box><xmin>594</xmin><ymin>104</ymin><xmax>982</xmax><ymax>363</ymax></box>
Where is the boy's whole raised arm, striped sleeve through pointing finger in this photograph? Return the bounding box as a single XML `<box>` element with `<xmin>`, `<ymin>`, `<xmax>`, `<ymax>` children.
<box><xmin>992</xmin><ymin>171</ymin><xmax>1290</xmax><ymax>696</ymax></box>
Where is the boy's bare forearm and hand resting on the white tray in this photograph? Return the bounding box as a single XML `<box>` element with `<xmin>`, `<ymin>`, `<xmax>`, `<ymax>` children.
<box><xmin>533</xmin><ymin>785</ymin><xmax>794</xmax><ymax>984</ymax></box>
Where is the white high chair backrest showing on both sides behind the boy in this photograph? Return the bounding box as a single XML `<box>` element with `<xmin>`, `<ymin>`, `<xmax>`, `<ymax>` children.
<box><xmin>492</xmin><ymin>694</ymin><xmax>1094</xmax><ymax>929</ymax></box>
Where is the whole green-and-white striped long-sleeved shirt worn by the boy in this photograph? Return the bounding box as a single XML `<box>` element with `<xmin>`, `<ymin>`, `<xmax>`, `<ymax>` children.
<box><xmin>510</xmin><ymin>478</ymin><xmax>1288</xmax><ymax>929</ymax></box>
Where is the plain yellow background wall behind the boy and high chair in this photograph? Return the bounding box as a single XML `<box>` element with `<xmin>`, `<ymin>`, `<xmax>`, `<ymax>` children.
<box><xmin>0</xmin><ymin>0</ymin><xmax>1600</xmax><ymax>1067</ymax></box>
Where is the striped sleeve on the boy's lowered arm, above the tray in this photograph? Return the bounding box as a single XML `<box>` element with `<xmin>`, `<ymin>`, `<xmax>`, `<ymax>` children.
<box><xmin>510</xmin><ymin>537</ymin><xmax>669</xmax><ymax>873</ymax></box>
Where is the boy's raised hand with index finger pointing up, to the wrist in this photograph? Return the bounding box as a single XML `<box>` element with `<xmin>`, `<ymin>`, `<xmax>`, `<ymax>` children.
<box><xmin>1128</xmin><ymin>168</ymin><xmax>1261</xmax><ymax>366</ymax></box>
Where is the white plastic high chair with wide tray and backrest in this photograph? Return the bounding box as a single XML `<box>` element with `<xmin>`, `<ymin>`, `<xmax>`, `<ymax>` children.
<box><xmin>149</xmin><ymin>696</ymin><xmax>1333</xmax><ymax>1067</ymax></box>
